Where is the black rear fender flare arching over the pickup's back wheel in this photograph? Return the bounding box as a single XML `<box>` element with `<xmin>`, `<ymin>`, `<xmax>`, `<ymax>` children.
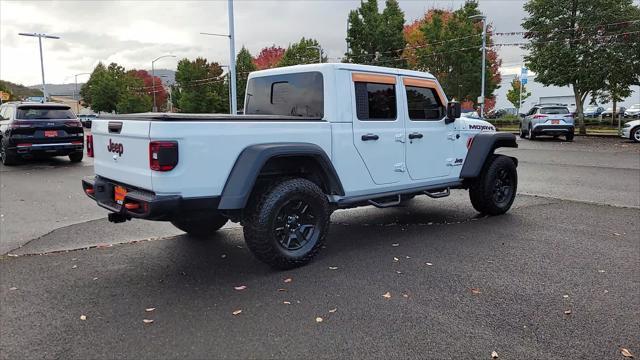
<box><xmin>218</xmin><ymin>142</ymin><xmax>344</xmax><ymax>210</ymax></box>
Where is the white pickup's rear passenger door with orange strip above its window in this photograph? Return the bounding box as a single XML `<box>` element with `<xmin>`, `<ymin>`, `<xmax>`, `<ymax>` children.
<box><xmin>351</xmin><ymin>73</ymin><xmax>405</xmax><ymax>184</ymax></box>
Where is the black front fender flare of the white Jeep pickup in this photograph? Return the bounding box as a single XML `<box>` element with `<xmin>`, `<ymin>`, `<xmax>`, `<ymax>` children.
<box><xmin>460</xmin><ymin>133</ymin><xmax>518</xmax><ymax>179</ymax></box>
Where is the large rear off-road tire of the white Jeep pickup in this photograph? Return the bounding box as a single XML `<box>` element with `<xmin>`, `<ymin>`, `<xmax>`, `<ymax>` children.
<box><xmin>243</xmin><ymin>178</ymin><xmax>331</xmax><ymax>270</ymax></box>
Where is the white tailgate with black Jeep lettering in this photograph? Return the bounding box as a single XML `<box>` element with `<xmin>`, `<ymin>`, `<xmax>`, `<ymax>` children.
<box><xmin>91</xmin><ymin>120</ymin><xmax>152</xmax><ymax>190</ymax></box>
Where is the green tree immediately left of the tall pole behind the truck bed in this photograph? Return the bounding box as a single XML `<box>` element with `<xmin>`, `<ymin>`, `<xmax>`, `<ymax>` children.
<box><xmin>176</xmin><ymin>58</ymin><xmax>229</xmax><ymax>113</ymax></box>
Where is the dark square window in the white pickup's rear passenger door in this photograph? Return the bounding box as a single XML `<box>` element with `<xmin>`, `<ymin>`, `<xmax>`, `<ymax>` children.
<box><xmin>355</xmin><ymin>82</ymin><xmax>397</xmax><ymax>121</ymax></box>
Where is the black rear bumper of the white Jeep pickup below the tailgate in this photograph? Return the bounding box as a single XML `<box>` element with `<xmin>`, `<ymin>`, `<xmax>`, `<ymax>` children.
<box><xmin>82</xmin><ymin>176</ymin><xmax>220</xmax><ymax>222</ymax></box>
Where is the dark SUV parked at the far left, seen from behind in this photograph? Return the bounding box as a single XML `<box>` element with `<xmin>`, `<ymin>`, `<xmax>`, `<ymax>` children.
<box><xmin>0</xmin><ymin>102</ymin><xmax>84</xmax><ymax>165</ymax></box>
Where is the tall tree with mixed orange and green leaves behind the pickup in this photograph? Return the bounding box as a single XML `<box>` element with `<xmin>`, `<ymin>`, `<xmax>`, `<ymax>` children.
<box><xmin>403</xmin><ymin>1</ymin><xmax>501</xmax><ymax>111</ymax></box>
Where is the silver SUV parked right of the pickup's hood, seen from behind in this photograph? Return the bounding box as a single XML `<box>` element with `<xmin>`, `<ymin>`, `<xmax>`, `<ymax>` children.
<box><xmin>520</xmin><ymin>104</ymin><xmax>575</xmax><ymax>141</ymax></box>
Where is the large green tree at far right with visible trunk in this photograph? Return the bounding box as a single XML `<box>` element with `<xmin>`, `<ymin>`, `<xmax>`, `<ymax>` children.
<box><xmin>522</xmin><ymin>0</ymin><xmax>640</xmax><ymax>134</ymax></box>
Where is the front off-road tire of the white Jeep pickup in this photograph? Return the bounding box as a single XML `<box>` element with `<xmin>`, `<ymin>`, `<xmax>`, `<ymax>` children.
<box><xmin>469</xmin><ymin>155</ymin><xmax>518</xmax><ymax>215</ymax></box>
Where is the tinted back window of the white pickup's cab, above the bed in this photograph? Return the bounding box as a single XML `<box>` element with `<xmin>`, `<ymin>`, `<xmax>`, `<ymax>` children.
<box><xmin>245</xmin><ymin>71</ymin><xmax>324</xmax><ymax>119</ymax></box>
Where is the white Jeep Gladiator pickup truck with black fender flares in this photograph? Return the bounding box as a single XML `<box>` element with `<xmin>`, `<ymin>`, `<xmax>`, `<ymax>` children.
<box><xmin>82</xmin><ymin>64</ymin><xmax>517</xmax><ymax>269</ymax></box>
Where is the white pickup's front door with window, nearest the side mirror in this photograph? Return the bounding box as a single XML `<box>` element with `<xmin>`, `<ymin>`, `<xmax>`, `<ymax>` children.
<box><xmin>402</xmin><ymin>77</ymin><xmax>452</xmax><ymax>180</ymax></box>
